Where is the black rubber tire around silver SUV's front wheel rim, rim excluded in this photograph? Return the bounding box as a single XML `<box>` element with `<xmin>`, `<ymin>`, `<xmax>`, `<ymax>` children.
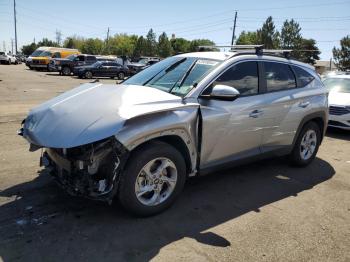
<box><xmin>119</xmin><ymin>142</ymin><xmax>186</xmax><ymax>217</ymax></box>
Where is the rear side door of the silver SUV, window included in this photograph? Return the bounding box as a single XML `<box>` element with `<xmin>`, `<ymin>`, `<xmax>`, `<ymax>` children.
<box><xmin>261</xmin><ymin>61</ymin><xmax>312</xmax><ymax>152</ymax></box>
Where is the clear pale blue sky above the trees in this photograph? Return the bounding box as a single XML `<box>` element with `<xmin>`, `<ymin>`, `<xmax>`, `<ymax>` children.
<box><xmin>0</xmin><ymin>0</ymin><xmax>350</xmax><ymax>60</ymax></box>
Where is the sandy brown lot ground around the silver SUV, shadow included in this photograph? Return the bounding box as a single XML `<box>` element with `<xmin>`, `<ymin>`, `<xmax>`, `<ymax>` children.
<box><xmin>0</xmin><ymin>65</ymin><xmax>350</xmax><ymax>261</ymax></box>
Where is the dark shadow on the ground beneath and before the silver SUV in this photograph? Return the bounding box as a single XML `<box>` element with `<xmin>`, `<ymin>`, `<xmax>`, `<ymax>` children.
<box><xmin>0</xmin><ymin>158</ymin><xmax>335</xmax><ymax>261</ymax></box>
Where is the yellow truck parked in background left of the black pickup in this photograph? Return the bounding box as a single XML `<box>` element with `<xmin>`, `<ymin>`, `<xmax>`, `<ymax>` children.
<box><xmin>28</xmin><ymin>47</ymin><xmax>80</xmax><ymax>70</ymax></box>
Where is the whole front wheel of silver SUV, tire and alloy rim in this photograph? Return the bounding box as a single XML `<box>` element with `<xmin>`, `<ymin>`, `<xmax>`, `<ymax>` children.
<box><xmin>119</xmin><ymin>142</ymin><xmax>186</xmax><ymax>216</ymax></box>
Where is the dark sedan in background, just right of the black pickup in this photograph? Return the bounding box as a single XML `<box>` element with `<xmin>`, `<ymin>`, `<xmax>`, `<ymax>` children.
<box><xmin>74</xmin><ymin>61</ymin><xmax>129</xmax><ymax>80</ymax></box>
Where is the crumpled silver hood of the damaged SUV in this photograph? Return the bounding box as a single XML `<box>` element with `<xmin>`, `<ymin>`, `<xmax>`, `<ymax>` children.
<box><xmin>23</xmin><ymin>83</ymin><xmax>190</xmax><ymax>148</ymax></box>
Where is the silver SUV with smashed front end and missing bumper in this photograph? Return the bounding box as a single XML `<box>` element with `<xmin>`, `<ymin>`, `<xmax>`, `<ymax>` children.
<box><xmin>19</xmin><ymin>50</ymin><xmax>328</xmax><ymax>216</ymax></box>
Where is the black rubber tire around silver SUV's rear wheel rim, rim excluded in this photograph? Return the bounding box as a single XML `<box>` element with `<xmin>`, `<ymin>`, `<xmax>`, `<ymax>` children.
<box><xmin>289</xmin><ymin>121</ymin><xmax>321</xmax><ymax>167</ymax></box>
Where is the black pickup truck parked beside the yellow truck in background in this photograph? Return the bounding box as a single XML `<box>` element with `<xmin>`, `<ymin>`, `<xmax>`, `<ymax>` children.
<box><xmin>49</xmin><ymin>54</ymin><xmax>98</xmax><ymax>76</ymax></box>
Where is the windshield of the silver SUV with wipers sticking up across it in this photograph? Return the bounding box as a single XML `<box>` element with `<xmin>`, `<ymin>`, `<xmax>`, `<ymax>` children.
<box><xmin>124</xmin><ymin>57</ymin><xmax>220</xmax><ymax>97</ymax></box>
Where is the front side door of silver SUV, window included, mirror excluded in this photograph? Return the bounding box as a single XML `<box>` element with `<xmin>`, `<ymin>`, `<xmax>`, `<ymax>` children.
<box><xmin>199</xmin><ymin>61</ymin><xmax>266</xmax><ymax>169</ymax></box>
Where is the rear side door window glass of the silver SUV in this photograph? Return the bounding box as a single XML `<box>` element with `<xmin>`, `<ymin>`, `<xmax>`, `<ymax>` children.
<box><xmin>263</xmin><ymin>62</ymin><xmax>297</xmax><ymax>92</ymax></box>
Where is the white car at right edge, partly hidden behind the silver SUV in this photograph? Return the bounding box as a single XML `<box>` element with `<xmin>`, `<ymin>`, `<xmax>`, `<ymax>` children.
<box><xmin>323</xmin><ymin>74</ymin><xmax>350</xmax><ymax>130</ymax></box>
